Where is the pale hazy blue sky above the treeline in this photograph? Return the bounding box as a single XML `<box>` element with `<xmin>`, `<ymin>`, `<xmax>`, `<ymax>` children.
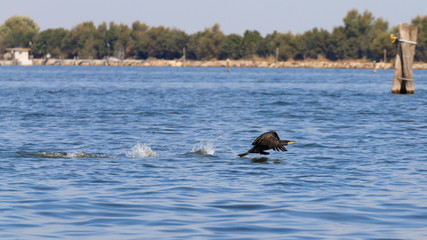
<box><xmin>0</xmin><ymin>0</ymin><xmax>427</xmax><ymax>35</ymax></box>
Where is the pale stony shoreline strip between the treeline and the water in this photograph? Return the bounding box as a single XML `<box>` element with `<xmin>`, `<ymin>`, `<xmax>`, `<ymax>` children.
<box><xmin>5</xmin><ymin>59</ymin><xmax>427</xmax><ymax>69</ymax></box>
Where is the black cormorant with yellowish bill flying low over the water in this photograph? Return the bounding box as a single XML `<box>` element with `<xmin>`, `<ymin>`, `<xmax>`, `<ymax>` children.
<box><xmin>239</xmin><ymin>131</ymin><xmax>295</xmax><ymax>157</ymax></box>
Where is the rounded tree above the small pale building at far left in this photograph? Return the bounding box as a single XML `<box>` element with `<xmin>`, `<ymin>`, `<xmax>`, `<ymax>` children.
<box><xmin>0</xmin><ymin>15</ymin><xmax>39</xmax><ymax>50</ymax></box>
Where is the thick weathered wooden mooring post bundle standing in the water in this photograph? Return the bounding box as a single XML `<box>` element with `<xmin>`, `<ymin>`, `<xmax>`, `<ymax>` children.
<box><xmin>390</xmin><ymin>23</ymin><xmax>417</xmax><ymax>94</ymax></box>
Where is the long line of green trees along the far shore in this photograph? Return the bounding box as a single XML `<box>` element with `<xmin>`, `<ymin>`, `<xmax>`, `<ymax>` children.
<box><xmin>0</xmin><ymin>9</ymin><xmax>427</xmax><ymax>61</ymax></box>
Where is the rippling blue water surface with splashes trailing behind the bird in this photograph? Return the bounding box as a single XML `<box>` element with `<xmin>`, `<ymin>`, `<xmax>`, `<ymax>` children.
<box><xmin>0</xmin><ymin>66</ymin><xmax>427</xmax><ymax>239</ymax></box>
